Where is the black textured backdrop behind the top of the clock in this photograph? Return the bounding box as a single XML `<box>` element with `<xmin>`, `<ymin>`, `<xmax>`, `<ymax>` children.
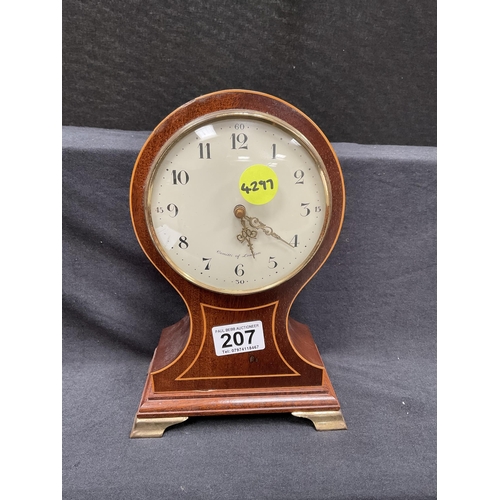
<box><xmin>62</xmin><ymin>0</ymin><xmax>437</xmax><ymax>146</ymax></box>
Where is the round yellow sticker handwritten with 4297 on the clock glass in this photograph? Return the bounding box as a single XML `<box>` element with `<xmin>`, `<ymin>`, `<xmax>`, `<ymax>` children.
<box><xmin>240</xmin><ymin>164</ymin><xmax>278</xmax><ymax>205</ymax></box>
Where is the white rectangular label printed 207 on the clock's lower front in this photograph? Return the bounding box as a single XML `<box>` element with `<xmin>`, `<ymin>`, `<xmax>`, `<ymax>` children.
<box><xmin>212</xmin><ymin>321</ymin><xmax>266</xmax><ymax>356</ymax></box>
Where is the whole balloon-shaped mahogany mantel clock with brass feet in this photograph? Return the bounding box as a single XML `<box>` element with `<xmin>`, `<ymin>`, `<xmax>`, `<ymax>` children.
<box><xmin>130</xmin><ymin>90</ymin><xmax>346</xmax><ymax>438</ymax></box>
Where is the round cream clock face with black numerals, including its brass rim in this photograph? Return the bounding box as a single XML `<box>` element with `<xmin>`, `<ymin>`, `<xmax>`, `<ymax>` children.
<box><xmin>145</xmin><ymin>110</ymin><xmax>331</xmax><ymax>294</ymax></box>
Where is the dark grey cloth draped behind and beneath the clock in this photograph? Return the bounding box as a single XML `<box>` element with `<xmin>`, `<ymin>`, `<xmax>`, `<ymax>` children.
<box><xmin>62</xmin><ymin>127</ymin><xmax>437</xmax><ymax>500</ymax></box>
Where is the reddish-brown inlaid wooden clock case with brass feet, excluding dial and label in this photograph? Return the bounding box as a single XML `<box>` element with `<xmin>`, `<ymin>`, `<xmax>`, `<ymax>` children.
<box><xmin>130</xmin><ymin>90</ymin><xmax>346</xmax><ymax>437</ymax></box>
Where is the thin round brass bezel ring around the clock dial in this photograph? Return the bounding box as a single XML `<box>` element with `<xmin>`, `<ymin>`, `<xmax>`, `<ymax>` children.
<box><xmin>144</xmin><ymin>109</ymin><xmax>332</xmax><ymax>295</ymax></box>
